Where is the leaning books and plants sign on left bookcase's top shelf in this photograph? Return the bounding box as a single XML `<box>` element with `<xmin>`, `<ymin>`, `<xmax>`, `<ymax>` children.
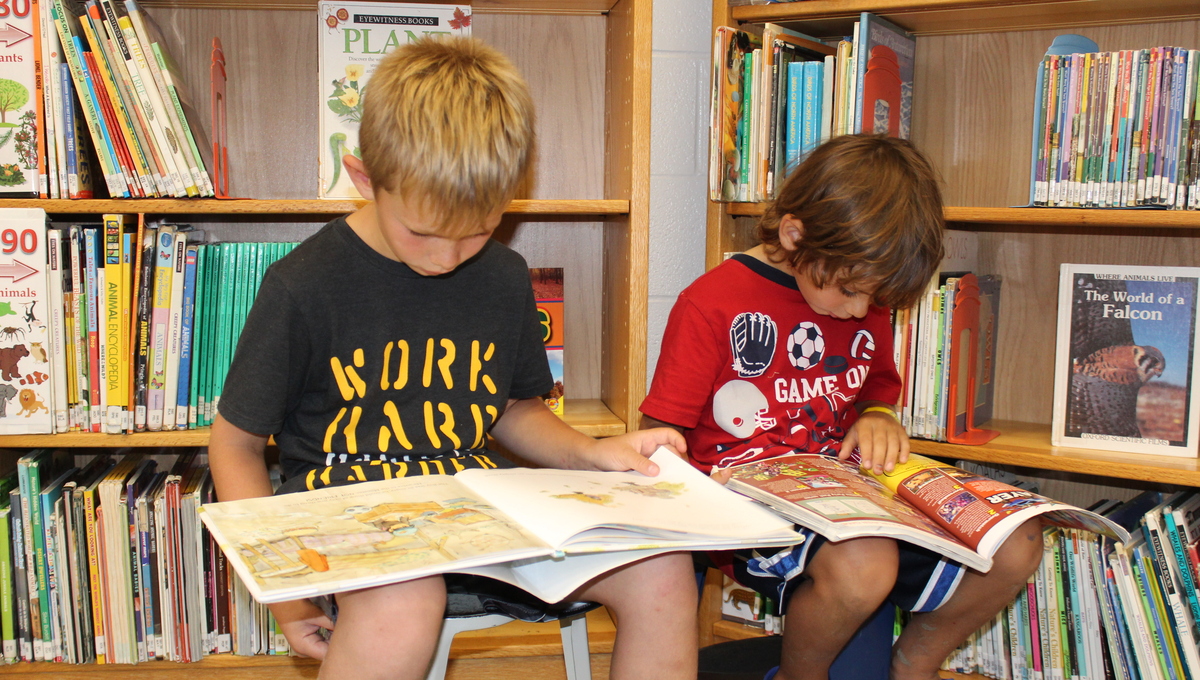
<box><xmin>0</xmin><ymin>0</ymin><xmax>215</xmax><ymax>198</ymax></box>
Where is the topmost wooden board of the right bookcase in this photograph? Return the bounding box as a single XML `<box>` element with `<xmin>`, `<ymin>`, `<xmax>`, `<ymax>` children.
<box><xmin>731</xmin><ymin>0</ymin><xmax>1200</xmax><ymax>37</ymax></box>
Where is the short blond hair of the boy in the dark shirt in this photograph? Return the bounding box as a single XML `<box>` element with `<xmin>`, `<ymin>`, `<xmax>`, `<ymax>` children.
<box><xmin>359</xmin><ymin>37</ymin><xmax>534</xmax><ymax>235</ymax></box>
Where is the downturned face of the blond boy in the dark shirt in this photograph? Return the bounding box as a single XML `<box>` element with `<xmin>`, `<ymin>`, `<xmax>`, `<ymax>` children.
<box><xmin>374</xmin><ymin>189</ymin><xmax>504</xmax><ymax>276</ymax></box>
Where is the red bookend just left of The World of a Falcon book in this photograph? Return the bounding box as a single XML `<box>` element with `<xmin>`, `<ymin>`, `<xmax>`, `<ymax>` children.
<box><xmin>946</xmin><ymin>273</ymin><xmax>1000</xmax><ymax>445</ymax></box>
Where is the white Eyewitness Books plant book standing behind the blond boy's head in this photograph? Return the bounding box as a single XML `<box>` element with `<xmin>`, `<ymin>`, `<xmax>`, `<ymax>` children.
<box><xmin>317</xmin><ymin>0</ymin><xmax>470</xmax><ymax>198</ymax></box>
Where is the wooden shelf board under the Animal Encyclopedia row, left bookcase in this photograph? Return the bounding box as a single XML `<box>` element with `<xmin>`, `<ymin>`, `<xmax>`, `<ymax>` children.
<box><xmin>0</xmin><ymin>399</ymin><xmax>625</xmax><ymax>449</ymax></box>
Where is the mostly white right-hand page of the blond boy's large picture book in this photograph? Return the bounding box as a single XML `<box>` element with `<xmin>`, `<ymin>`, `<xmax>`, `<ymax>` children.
<box><xmin>457</xmin><ymin>449</ymin><xmax>798</xmax><ymax>552</ymax></box>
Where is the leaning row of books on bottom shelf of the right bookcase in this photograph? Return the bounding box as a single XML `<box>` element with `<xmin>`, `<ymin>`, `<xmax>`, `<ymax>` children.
<box><xmin>946</xmin><ymin>491</ymin><xmax>1200</xmax><ymax>680</ymax></box>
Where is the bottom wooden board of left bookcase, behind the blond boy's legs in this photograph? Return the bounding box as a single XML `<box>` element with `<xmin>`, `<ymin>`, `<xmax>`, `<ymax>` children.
<box><xmin>0</xmin><ymin>607</ymin><xmax>617</xmax><ymax>678</ymax></box>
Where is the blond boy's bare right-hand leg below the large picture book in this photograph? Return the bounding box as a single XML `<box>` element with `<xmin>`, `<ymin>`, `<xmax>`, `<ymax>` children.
<box><xmin>575</xmin><ymin>553</ymin><xmax>700</xmax><ymax>680</ymax></box>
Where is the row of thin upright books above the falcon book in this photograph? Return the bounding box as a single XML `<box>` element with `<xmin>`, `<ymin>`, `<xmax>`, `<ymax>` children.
<box><xmin>1030</xmin><ymin>41</ymin><xmax>1200</xmax><ymax>210</ymax></box>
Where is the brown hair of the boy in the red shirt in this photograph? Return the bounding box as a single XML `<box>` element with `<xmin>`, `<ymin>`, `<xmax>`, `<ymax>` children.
<box><xmin>758</xmin><ymin>134</ymin><xmax>946</xmax><ymax>308</ymax></box>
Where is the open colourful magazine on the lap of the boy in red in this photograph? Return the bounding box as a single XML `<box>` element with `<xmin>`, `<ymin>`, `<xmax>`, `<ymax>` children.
<box><xmin>728</xmin><ymin>455</ymin><xmax>1129</xmax><ymax>572</ymax></box>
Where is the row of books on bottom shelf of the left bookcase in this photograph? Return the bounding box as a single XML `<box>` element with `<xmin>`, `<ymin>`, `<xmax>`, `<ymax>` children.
<box><xmin>0</xmin><ymin>450</ymin><xmax>288</xmax><ymax>663</ymax></box>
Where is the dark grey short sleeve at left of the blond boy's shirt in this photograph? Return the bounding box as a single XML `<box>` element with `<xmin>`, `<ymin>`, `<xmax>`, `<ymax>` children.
<box><xmin>217</xmin><ymin>270</ymin><xmax>310</xmax><ymax>434</ymax></box>
